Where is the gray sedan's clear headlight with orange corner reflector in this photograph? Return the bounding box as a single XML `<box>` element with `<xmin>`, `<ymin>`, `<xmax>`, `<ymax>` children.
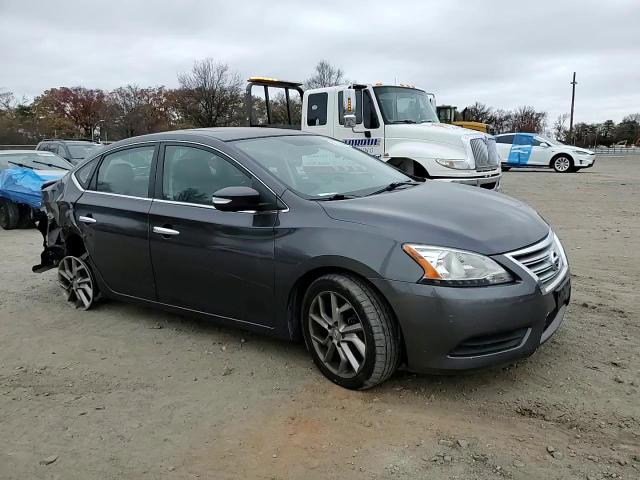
<box><xmin>402</xmin><ymin>243</ymin><xmax>513</xmax><ymax>287</ymax></box>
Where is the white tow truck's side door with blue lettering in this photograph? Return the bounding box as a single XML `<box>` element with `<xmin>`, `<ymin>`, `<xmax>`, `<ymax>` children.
<box><xmin>334</xmin><ymin>89</ymin><xmax>384</xmax><ymax>158</ymax></box>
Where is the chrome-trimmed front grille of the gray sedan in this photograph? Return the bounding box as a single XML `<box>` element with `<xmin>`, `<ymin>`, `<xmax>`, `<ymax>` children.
<box><xmin>507</xmin><ymin>233</ymin><xmax>567</xmax><ymax>293</ymax></box>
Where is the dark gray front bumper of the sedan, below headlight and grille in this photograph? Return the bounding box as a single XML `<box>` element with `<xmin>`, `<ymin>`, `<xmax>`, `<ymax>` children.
<box><xmin>372</xmin><ymin>271</ymin><xmax>571</xmax><ymax>373</ymax></box>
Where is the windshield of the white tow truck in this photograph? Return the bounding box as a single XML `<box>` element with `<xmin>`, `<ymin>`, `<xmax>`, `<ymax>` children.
<box><xmin>373</xmin><ymin>87</ymin><xmax>439</xmax><ymax>124</ymax></box>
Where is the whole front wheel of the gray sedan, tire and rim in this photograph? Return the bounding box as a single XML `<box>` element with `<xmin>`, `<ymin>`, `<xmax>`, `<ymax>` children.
<box><xmin>302</xmin><ymin>274</ymin><xmax>400</xmax><ymax>390</ymax></box>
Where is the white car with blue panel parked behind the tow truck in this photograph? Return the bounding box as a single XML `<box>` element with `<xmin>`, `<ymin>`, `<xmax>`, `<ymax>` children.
<box><xmin>496</xmin><ymin>133</ymin><xmax>595</xmax><ymax>173</ymax></box>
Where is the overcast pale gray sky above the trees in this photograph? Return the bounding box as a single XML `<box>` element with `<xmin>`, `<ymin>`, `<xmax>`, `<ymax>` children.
<box><xmin>0</xmin><ymin>0</ymin><xmax>640</xmax><ymax>124</ymax></box>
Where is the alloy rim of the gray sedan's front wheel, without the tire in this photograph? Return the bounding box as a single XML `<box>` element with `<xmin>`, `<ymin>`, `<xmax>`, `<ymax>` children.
<box><xmin>307</xmin><ymin>292</ymin><xmax>367</xmax><ymax>378</ymax></box>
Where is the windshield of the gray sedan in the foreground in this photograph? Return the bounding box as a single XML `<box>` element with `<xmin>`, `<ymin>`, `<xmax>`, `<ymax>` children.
<box><xmin>234</xmin><ymin>135</ymin><xmax>411</xmax><ymax>200</ymax></box>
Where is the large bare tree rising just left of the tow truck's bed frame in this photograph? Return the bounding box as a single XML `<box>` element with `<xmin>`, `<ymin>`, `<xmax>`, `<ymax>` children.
<box><xmin>176</xmin><ymin>58</ymin><xmax>242</xmax><ymax>127</ymax></box>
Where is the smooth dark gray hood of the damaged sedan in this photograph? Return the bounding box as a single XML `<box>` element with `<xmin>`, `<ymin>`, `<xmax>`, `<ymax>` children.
<box><xmin>320</xmin><ymin>180</ymin><xmax>549</xmax><ymax>255</ymax></box>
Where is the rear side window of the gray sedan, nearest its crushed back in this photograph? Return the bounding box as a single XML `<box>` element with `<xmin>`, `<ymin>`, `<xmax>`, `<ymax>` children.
<box><xmin>96</xmin><ymin>146</ymin><xmax>155</xmax><ymax>198</ymax></box>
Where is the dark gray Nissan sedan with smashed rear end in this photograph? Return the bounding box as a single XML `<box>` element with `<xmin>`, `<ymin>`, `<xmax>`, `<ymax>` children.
<box><xmin>34</xmin><ymin>128</ymin><xmax>571</xmax><ymax>389</ymax></box>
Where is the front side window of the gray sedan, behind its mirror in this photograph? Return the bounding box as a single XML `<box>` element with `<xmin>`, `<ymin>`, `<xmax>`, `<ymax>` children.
<box><xmin>162</xmin><ymin>145</ymin><xmax>255</xmax><ymax>205</ymax></box>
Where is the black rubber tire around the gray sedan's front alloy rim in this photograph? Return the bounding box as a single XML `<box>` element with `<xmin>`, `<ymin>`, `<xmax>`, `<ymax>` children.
<box><xmin>301</xmin><ymin>274</ymin><xmax>401</xmax><ymax>390</ymax></box>
